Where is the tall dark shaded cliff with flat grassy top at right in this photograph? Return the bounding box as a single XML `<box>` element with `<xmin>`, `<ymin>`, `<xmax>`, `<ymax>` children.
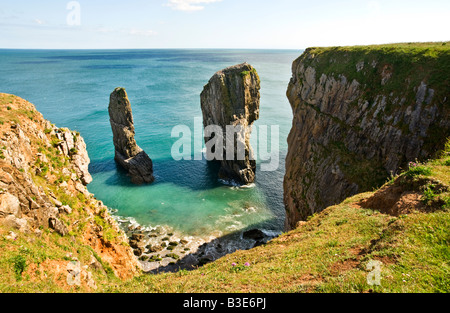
<box><xmin>284</xmin><ymin>44</ymin><xmax>450</xmax><ymax>229</ymax></box>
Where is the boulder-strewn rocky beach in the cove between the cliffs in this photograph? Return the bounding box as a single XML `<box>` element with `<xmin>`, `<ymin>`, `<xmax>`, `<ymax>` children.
<box><xmin>112</xmin><ymin>211</ymin><xmax>279</xmax><ymax>273</ymax></box>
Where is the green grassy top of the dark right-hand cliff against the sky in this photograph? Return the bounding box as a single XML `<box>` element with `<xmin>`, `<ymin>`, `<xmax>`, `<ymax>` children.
<box><xmin>299</xmin><ymin>42</ymin><xmax>450</xmax><ymax>94</ymax></box>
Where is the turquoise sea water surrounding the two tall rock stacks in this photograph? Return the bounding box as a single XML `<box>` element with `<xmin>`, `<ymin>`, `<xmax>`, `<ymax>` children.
<box><xmin>0</xmin><ymin>50</ymin><xmax>301</xmax><ymax>236</ymax></box>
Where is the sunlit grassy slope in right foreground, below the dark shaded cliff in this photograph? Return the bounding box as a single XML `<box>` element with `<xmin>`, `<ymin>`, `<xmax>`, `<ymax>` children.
<box><xmin>107</xmin><ymin>141</ymin><xmax>450</xmax><ymax>293</ymax></box>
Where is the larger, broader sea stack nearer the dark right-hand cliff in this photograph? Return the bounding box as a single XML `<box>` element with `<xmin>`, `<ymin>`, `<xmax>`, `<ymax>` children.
<box><xmin>201</xmin><ymin>63</ymin><xmax>260</xmax><ymax>185</ymax></box>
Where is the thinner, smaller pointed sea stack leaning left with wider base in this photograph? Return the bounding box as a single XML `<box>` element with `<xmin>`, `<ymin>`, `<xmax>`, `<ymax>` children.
<box><xmin>109</xmin><ymin>88</ymin><xmax>155</xmax><ymax>185</ymax></box>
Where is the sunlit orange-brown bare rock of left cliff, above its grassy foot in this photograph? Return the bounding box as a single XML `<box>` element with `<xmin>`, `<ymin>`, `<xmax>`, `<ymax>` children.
<box><xmin>0</xmin><ymin>94</ymin><xmax>139</xmax><ymax>280</ymax></box>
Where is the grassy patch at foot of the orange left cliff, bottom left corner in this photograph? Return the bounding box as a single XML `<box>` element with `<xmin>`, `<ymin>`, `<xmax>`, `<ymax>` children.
<box><xmin>0</xmin><ymin>228</ymin><xmax>125</xmax><ymax>293</ymax></box>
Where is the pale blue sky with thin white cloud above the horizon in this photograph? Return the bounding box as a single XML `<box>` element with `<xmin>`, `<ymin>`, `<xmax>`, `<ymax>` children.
<box><xmin>0</xmin><ymin>0</ymin><xmax>450</xmax><ymax>49</ymax></box>
